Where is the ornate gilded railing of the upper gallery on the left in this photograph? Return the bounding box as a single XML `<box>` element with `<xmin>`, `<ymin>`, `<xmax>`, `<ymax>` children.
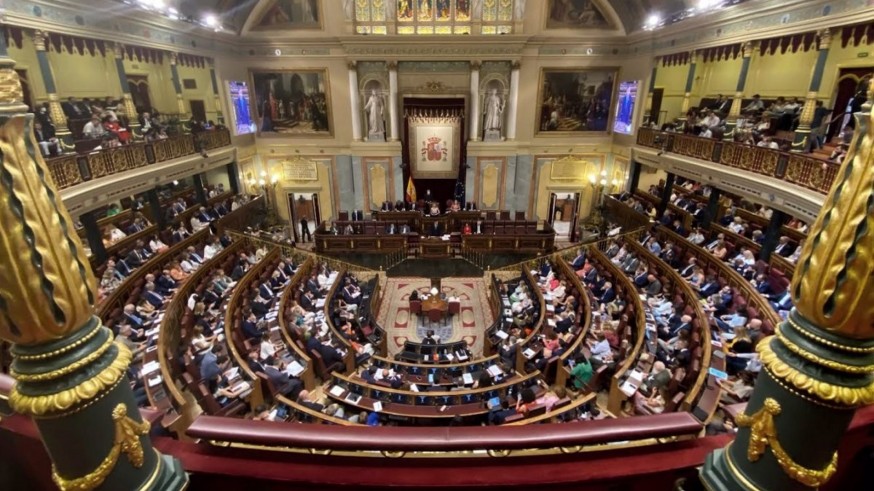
<box><xmin>46</xmin><ymin>129</ymin><xmax>231</xmax><ymax>189</ymax></box>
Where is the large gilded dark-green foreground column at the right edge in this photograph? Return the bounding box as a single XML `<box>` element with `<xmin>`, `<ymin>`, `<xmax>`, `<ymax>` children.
<box><xmin>701</xmin><ymin>79</ymin><xmax>874</xmax><ymax>491</ymax></box>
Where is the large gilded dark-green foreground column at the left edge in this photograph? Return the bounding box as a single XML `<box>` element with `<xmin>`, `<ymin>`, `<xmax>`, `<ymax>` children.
<box><xmin>0</xmin><ymin>37</ymin><xmax>188</xmax><ymax>490</ymax></box>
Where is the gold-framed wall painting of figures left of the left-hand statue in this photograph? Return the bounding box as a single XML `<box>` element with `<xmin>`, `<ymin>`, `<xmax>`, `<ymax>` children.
<box><xmin>252</xmin><ymin>69</ymin><xmax>334</xmax><ymax>136</ymax></box>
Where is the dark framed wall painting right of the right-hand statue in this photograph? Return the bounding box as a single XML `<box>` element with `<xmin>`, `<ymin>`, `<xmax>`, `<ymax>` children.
<box><xmin>535</xmin><ymin>68</ymin><xmax>618</xmax><ymax>135</ymax></box>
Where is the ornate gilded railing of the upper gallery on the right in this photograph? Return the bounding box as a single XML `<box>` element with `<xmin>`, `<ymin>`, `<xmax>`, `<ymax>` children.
<box><xmin>637</xmin><ymin>128</ymin><xmax>840</xmax><ymax>194</ymax></box>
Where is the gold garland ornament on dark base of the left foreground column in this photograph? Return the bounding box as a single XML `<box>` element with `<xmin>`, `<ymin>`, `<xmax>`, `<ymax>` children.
<box><xmin>52</xmin><ymin>404</ymin><xmax>150</xmax><ymax>491</ymax></box>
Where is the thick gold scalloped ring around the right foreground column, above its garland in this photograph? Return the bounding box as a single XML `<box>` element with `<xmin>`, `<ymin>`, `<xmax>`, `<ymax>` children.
<box><xmin>757</xmin><ymin>338</ymin><xmax>874</xmax><ymax>407</ymax></box>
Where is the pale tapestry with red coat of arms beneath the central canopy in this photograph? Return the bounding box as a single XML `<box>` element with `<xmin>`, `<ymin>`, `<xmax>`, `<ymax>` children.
<box><xmin>407</xmin><ymin>116</ymin><xmax>461</xmax><ymax>179</ymax></box>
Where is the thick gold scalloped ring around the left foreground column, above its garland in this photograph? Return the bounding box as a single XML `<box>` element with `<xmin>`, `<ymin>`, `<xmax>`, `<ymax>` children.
<box><xmin>9</xmin><ymin>344</ymin><xmax>131</xmax><ymax>416</ymax></box>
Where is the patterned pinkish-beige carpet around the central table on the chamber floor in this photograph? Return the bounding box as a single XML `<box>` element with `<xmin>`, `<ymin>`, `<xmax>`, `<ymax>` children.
<box><xmin>377</xmin><ymin>278</ymin><xmax>493</xmax><ymax>356</ymax></box>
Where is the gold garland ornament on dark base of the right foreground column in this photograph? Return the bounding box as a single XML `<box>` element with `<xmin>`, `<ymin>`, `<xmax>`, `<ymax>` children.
<box><xmin>735</xmin><ymin>397</ymin><xmax>838</xmax><ymax>488</ymax></box>
